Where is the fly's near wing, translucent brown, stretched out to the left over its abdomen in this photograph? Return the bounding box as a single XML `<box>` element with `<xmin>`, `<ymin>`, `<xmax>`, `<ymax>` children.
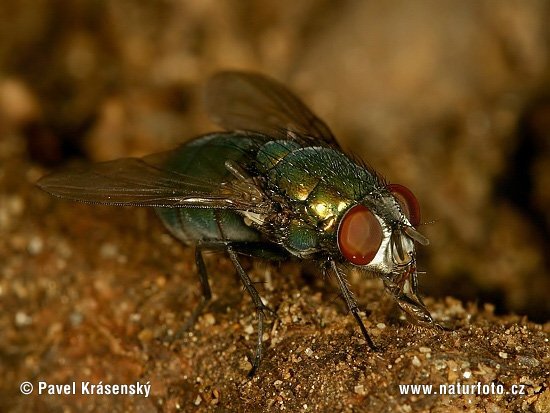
<box><xmin>37</xmin><ymin>151</ymin><xmax>261</xmax><ymax>211</ymax></box>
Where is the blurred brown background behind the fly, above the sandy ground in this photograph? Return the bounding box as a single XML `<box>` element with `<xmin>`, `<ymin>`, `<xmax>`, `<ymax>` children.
<box><xmin>0</xmin><ymin>0</ymin><xmax>550</xmax><ymax>322</ymax></box>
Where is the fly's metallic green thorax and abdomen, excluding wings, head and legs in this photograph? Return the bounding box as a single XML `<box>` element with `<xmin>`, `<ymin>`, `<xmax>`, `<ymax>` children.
<box><xmin>153</xmin><ymin>133</ymin><xmax>380</xmax><ymax>258</ymax></box>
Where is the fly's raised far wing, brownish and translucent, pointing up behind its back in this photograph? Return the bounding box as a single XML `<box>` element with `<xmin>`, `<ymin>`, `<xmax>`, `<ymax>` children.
<box><xmin>204</xmin><ymin>72</ymin><xmax>341</xmax><ymax>150</ymax></box>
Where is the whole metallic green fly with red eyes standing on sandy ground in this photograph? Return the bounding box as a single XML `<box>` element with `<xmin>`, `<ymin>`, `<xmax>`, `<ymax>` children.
<box><xmin>38</xmin><ymin>72</ymin><xmax>437</xmax><ymax>376</ymax></box>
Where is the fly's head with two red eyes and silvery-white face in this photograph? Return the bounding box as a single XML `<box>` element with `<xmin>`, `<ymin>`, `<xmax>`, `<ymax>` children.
<box><xmin>338</xmin><ymin>184</ymin><xmax>428</xmax><ymax>288</ymax></box>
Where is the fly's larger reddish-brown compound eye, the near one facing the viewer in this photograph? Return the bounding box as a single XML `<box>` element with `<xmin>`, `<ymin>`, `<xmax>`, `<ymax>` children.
<box><xmin>338</xmin><ymin>205</ymin><xmax>383</xmax><ymax>265</ymax></box>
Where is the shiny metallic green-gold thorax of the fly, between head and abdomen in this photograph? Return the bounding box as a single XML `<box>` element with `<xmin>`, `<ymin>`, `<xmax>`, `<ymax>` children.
<box><xmin>257</xmin><ymin>141</ymin><xmax>379</xmax><ymax>257</ymax></box>
